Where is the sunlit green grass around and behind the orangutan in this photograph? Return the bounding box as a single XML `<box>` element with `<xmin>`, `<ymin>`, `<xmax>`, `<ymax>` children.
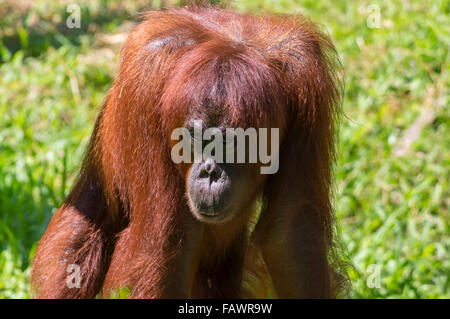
<box><xmin>0</xmin><ymin>0</ymin><xmax>450</xmax><ymax>298</ymax></box>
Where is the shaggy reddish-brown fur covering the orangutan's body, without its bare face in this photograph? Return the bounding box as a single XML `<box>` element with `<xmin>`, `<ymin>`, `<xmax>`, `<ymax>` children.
<box><xmin>32</xmin><ymin>7</ymin><xmax>347</xmax><ymax>298</ymax></box>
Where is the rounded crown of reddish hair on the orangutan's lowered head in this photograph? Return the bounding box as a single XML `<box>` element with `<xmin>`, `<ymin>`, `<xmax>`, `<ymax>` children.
<box><xmin>174</xmin><ymin>54</ymin><xmax>284</xmax><ymax>127</ymax></box>
